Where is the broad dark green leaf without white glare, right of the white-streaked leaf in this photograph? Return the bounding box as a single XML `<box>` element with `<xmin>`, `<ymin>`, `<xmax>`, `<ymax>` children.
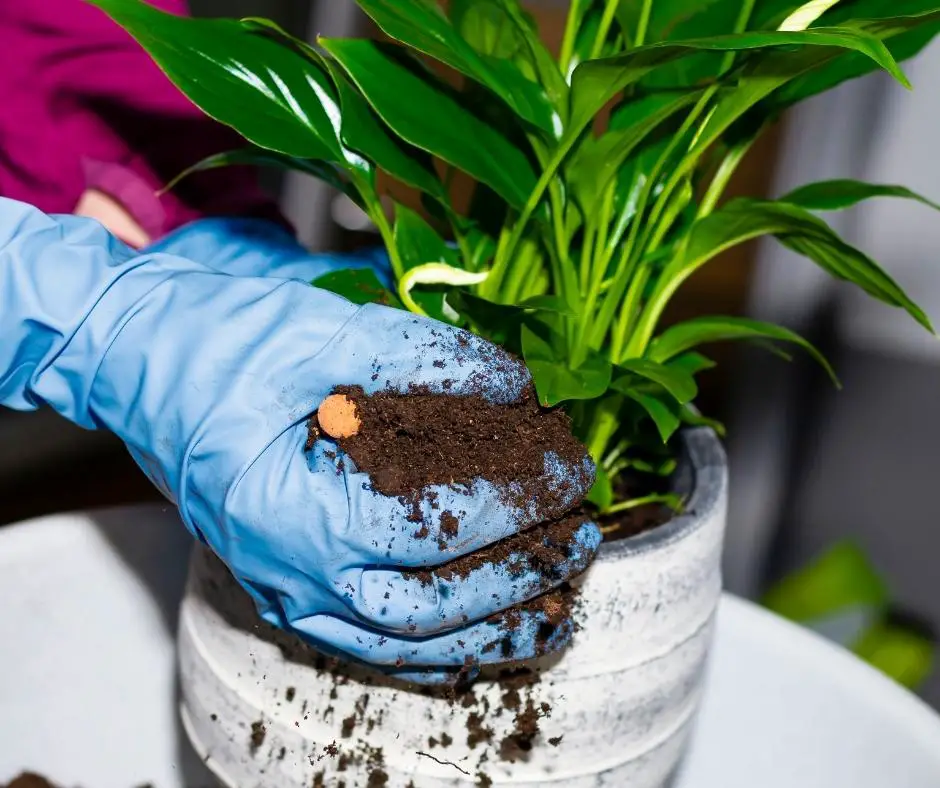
<box><xmin>321</xmin><ymin>39</ymin><xmax>536</xmax><ymax>208</ymax></box>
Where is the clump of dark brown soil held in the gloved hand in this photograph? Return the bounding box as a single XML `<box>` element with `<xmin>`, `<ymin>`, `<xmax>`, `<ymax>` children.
<box><xmin>309</xmin><ymin>386</ymin><xmax>590</xmax><ymax>535</ymax></box>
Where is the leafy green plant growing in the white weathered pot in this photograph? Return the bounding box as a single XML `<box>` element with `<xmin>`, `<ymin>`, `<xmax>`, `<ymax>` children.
<box><xmin>91</xmin><ymin>0</ymin><xmax>940</xmax><ymax>513</ymax></box>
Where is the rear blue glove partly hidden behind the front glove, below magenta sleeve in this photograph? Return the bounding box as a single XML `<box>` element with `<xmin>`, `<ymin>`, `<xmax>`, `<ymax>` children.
<box><xmin>142</xmin><ymin>217</ymin><xmax>391</xmax><ymax>287</ymax></box>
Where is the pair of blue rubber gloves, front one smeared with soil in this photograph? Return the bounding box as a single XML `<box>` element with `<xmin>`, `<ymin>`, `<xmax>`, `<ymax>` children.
<box><xmin>0</xmin><ymin>199</ymin><xmax>600</xmax><ymax>681</ymax></box>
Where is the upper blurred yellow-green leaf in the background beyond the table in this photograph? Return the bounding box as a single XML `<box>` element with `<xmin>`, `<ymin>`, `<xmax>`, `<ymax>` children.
<box><xmin>763</xmin><ymin>542</ymin><xmax>888</xmax><ymax>623</ymax></box>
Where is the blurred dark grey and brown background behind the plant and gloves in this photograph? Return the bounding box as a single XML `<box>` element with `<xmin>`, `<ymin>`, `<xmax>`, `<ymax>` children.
<box><xmin>0</xmin><ymin>0</ymin><xmax>940</xmax><ymax>708</ymax></box>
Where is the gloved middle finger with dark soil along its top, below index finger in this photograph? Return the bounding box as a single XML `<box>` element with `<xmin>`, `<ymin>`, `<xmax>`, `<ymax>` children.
<box><xmin>344</xmin><ymin>517</ymin><xmax>602</xmax><ymax>635</ymax></box>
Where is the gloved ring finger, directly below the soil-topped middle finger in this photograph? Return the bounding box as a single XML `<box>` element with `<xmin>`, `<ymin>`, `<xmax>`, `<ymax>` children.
<box><xmin>290</xmin><ymin>591</ymin><xmax>574</xmax><ymax>668</ymax></box>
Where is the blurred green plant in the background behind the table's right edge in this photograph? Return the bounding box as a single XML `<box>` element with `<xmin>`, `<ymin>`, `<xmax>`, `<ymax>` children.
<box><xmin>762</xmin><ymin>541</ymin><xmax>936</xmax><ymax>689</ymax></box>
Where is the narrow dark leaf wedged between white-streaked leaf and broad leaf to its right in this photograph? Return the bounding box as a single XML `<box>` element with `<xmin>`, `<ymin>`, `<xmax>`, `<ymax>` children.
<box><xmin>331</xmin><ymin>64</ymin><xmax>449</xmax><ymax>204</ymax></box>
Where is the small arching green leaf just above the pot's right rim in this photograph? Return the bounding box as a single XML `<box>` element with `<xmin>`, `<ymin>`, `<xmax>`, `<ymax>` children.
<box><xmin>648</xmin><ymin>317</ymin><xmax>839</xmax><ymax>386</ymax></box>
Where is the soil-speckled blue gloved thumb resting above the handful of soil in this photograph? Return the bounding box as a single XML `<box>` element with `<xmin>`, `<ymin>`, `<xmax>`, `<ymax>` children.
<box><xmin>317</xmin><ymin>304</ymin><xmax>531</xmax><ymax>404</ymax></box>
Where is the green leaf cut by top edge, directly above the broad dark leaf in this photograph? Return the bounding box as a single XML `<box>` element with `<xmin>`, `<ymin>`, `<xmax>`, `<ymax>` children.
<box><xmin>350</xmin><ymin>0</ymin><xmax>557</xmax><ymax>134</ymax></box>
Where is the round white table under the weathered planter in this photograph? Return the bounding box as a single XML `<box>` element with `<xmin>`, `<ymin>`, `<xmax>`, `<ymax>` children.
<box><xmin>0</xmin><ymin>506</ymin><xmax>940</xmax><ymax>788</ymax></box>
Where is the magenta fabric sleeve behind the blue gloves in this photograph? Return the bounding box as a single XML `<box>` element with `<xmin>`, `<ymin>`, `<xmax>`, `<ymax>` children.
<box><xmin>0</xmin><ymin>0</ymin><xmax>286</xmax><ymax>239</ymax></box>
